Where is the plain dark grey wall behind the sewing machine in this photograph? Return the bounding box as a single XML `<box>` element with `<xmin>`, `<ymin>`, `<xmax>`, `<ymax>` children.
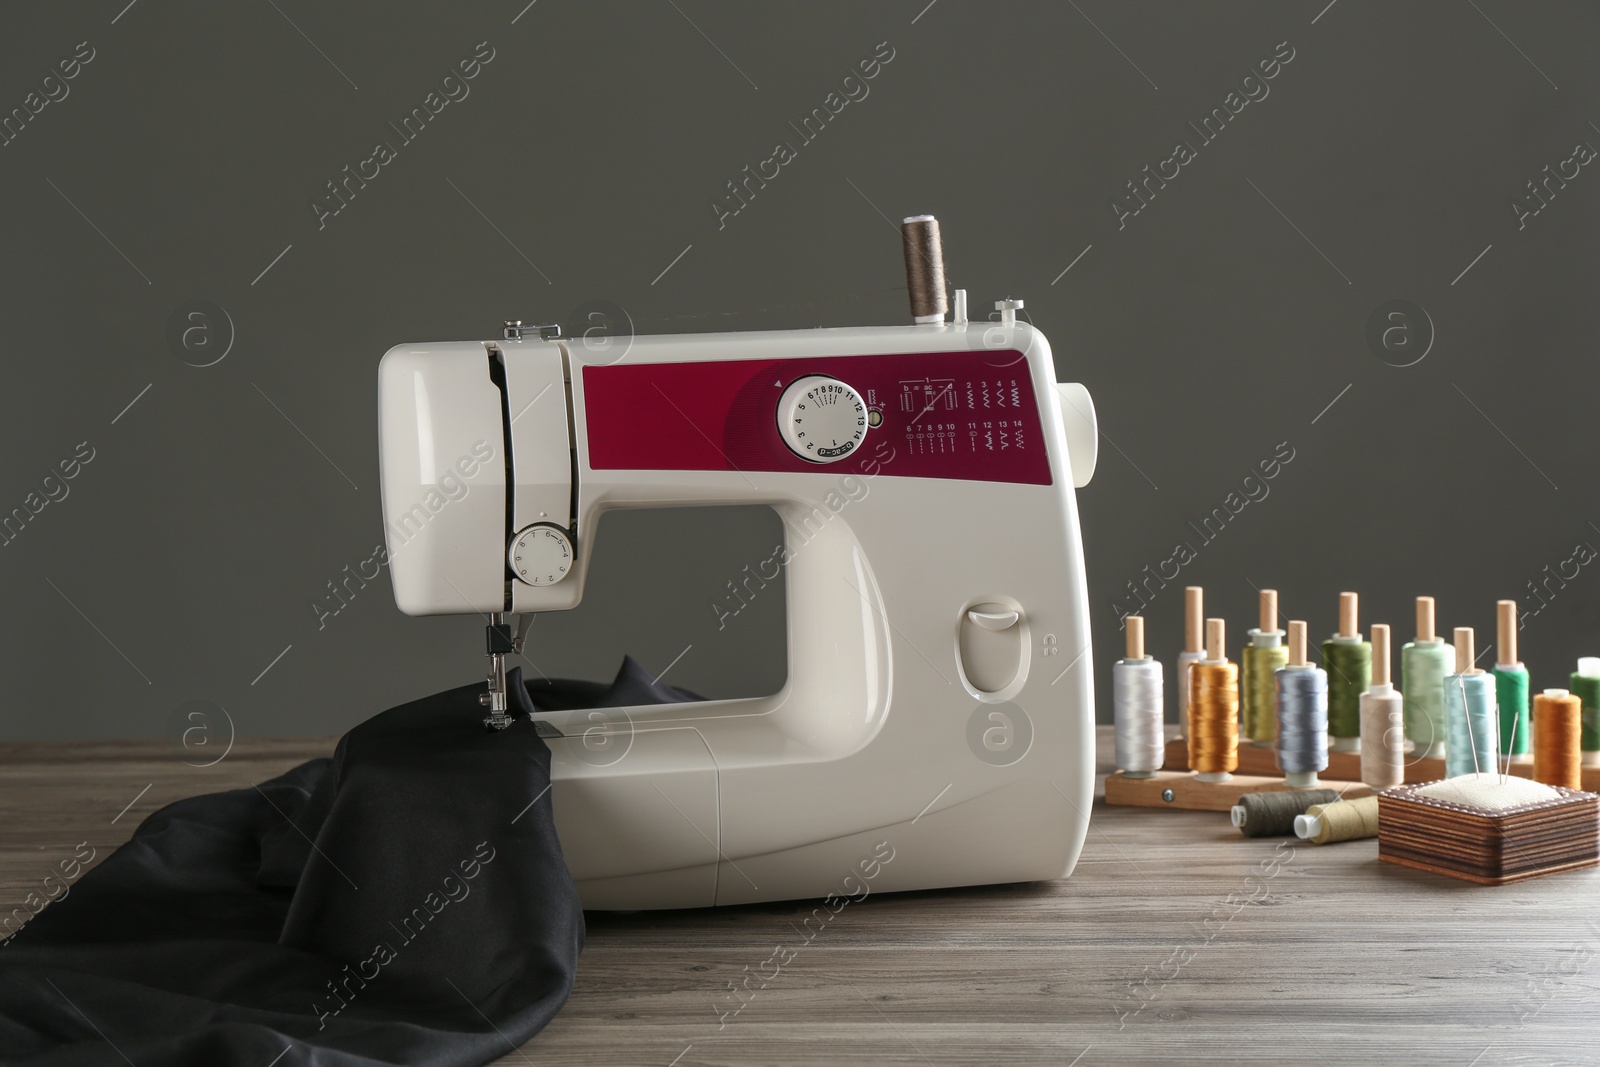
<box><xmin>0</xmin><ymin>0</ymin><xmax>1600</xmax><ymax>739</ymax></box>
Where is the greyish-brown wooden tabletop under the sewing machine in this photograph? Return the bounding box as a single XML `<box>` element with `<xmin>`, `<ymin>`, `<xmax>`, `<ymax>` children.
<box><xmin>0</xmin><ymin>731</ymin><xmax>1600</xmax><ymax>1067</ymax></box>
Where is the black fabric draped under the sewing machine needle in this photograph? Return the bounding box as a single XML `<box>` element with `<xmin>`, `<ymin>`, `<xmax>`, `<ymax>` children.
<box><xmin>0</xmin><ymin>659</ymin><xmax>699</xmax><ymax>1067</ymax></box>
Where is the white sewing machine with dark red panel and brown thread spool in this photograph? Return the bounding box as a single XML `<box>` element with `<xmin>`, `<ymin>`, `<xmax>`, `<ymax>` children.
<box><xmin>379</xmin><ymin>216</ymin><xmax>1098</xmax><ymax>909</ymax></box>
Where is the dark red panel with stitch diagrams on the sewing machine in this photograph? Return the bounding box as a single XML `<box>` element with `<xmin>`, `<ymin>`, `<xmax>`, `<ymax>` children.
<box><xmin>582</xmin><ymin>349</ymin><xmax>1051</xmax><ymax>485</ymax></box>
